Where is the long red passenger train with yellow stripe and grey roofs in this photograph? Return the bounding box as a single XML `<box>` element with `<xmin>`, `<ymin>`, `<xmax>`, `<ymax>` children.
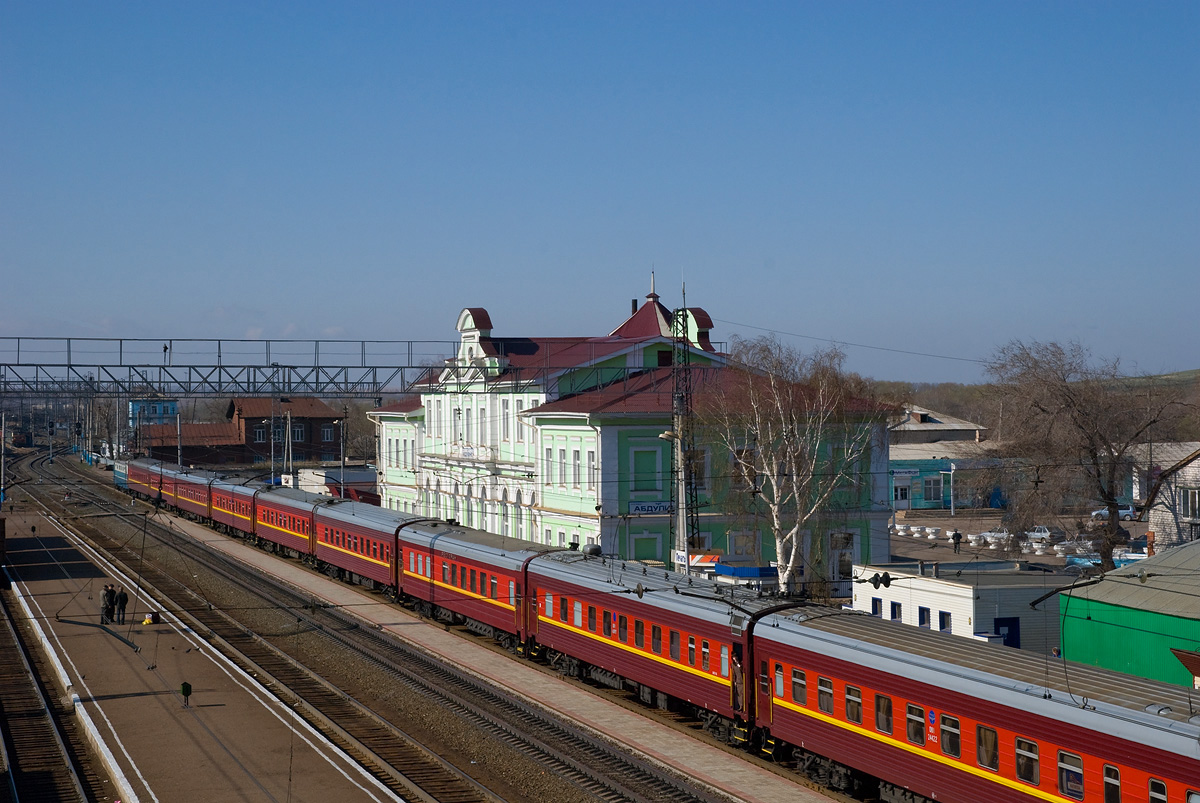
<box><xmin>114</xmin><ymin>460</ymin><xmax>1200</xmax><ymax>803</ymax></box>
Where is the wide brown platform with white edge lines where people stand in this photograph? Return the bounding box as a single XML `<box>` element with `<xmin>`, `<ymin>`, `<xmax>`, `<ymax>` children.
<box><xmin>6</xmin><ymin>514</ymin><xmax>398</xmax><ymax>803</ymax></box>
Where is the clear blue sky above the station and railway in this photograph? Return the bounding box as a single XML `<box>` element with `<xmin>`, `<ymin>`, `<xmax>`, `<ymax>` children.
<box><xmin>0</xmin><ymin>0</ymin><xmax>1200</xmax><ymax>382</ymax></box>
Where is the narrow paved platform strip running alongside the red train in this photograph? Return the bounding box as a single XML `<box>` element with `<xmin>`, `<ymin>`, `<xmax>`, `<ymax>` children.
<box><xmin>154</xmin><ymin>506</ymin><xmax>830</xmax><ymax>803</ymax></box>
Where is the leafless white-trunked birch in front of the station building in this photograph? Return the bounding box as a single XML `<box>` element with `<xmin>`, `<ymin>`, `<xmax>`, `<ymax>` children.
<box><xmin>695</xmin><ymin>337</ymin><xmax>887</xmax><ymax>597</ymax></box>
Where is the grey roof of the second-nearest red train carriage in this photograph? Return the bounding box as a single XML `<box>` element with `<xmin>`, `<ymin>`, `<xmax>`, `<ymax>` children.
<box><xmin>529</xmin><ymin>551</ymin><xmax>788</xmax><ymax>630</ymax></box>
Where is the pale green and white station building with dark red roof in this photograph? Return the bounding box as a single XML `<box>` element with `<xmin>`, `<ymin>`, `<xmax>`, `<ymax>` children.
<box><xmin>368</xmin><ymin>280</ymin><xmax>887</xmax><ymax>588</ymax></box>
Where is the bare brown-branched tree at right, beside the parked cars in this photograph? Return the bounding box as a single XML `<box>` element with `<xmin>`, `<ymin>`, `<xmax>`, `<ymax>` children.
<box><xmin>988</xmin><ymin>341</ymin><xmax>1184</xmax><ymax>570</ymax></box>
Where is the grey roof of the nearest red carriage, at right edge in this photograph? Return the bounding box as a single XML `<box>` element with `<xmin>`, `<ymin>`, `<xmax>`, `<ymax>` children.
<box><xmin>756</xmin><ymin>607</ymin><xmax>1200</xmax><ymax>759</ymax></box>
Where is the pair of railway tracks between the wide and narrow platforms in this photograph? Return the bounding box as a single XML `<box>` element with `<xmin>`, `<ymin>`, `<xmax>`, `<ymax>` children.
<box><xmin>16</xmin><ymin>451</ymin><xmax>727</xmax><ymax>803</ymax></box>
